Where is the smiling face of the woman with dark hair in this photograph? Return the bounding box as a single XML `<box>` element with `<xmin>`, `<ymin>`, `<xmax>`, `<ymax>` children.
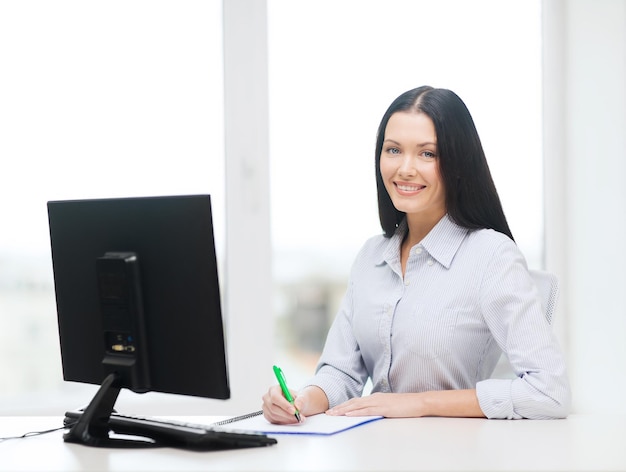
<box><xmin>380</xmin><ymin>112</ymin><xmax>446</xmax><ymax>222</ymax></box>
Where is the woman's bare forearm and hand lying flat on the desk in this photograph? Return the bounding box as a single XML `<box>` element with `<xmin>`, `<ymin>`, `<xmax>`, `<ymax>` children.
<box><xmin>327</xmin><ymin>389</ymin><xmax>485</xmax><ymax>418</ymax></box>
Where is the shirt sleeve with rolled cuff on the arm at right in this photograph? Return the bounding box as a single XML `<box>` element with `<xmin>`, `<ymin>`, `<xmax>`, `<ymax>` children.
<box><xmin>476</xmin><ymin>242</ymin><xmax>571</xmax><ymax>419</ymax></box>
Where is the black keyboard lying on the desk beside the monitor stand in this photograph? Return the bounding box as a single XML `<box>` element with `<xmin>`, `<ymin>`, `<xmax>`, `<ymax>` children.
<box><xmin>64</xmin><ymin>411</ymin><xmax>277</xmax><ymax>450</ymax></box>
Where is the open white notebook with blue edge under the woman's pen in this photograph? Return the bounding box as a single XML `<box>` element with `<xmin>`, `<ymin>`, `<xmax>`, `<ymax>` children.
<box><xmin>212</xmin><ymin>411</ymin><xmax>382</xmax><ymax>436</ymax></box>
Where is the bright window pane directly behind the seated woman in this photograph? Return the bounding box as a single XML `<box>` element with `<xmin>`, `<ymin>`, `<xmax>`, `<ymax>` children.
<box><xmin>268</xmin><ymin>0</ymin><xmax>543</xmax><ymax>388</ymax></box>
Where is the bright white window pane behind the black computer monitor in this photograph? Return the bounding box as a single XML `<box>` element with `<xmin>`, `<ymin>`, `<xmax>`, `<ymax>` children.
<box><xmin>0</xmin><ymin>0</ymin><xmax>224</xmax><ymax>414</ymax></box>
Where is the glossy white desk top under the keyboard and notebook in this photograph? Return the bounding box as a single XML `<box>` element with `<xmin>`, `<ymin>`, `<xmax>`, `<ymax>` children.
<box><xmin>0</xmin><ymin>415</ymin><xmax>626</xmax><ymax>471</ymax></box>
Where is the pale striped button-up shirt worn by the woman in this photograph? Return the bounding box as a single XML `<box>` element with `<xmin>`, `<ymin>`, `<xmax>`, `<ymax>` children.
<box><xmin>311</xmin><ymin>216</ymin><xmax>570</xmax><ymax>418</ymax></box>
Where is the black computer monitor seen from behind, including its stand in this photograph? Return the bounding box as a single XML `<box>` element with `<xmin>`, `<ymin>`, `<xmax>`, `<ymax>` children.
<box><xmin>48</xmin><ymin>195</ymin><xmax>230</xmax><ymax>445</ymax></box>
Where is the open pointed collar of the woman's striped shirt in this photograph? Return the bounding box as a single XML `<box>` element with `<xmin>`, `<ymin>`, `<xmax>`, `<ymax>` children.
<box><xmin>379</xmin><ymin>214</ymin><xmax>470</xmax><ymax>269</ymax></box>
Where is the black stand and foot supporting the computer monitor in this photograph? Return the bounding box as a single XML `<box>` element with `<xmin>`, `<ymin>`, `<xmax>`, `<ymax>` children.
<box><xmin>63</xmin><ymin>372</ymin><xmax>157</xmax><ymax>448</ymax></box>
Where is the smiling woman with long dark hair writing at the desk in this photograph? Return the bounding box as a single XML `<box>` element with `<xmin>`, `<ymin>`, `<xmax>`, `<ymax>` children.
<box><xmin>263</xmin><ymin>86</ymin><xmax>571</xmax><ymax>424</ymax></box>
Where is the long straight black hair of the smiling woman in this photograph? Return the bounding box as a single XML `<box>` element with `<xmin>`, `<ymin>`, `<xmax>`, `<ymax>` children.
<box><xmin>376</xmin><ymin>86</ymin><xmax>513</xmax><ymax>239</ymax></box>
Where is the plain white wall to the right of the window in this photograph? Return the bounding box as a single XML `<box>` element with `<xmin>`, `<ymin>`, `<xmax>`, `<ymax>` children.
<box><xmin>543</xmin><ymin>0</ymin><xmax>626</xmax><ymax>413</ymax></box>
